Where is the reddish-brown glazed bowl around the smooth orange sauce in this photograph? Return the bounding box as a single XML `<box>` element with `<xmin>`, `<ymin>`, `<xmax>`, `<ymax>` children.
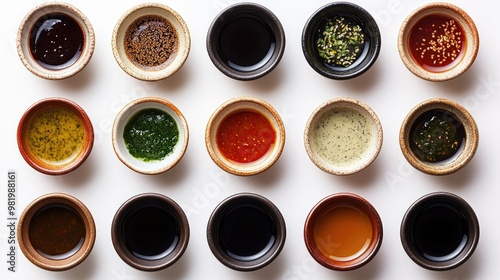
<box><xmin>304</xmin><ymin>193</ymin><xmax>383</xmax><ymax>271</ymax></box>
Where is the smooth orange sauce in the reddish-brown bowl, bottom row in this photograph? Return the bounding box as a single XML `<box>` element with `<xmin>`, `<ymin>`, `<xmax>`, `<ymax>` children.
<box><xmin>314</xmin><ymin>205</ymin><xmax>373</xmax><ymax>261</ymax></box>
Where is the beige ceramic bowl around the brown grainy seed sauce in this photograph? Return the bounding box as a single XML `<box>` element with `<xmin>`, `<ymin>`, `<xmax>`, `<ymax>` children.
<box><xmin>111</xmin><ymin>3</ymin><xmax>191</xmax><ymax>81</ymax></box>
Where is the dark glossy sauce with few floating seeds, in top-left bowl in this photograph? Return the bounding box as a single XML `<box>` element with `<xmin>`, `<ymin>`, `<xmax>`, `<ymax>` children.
<box><xmin>29</xmin><ymin>13</ymin><xmax>84</xmax><ymax>70</ymax></box>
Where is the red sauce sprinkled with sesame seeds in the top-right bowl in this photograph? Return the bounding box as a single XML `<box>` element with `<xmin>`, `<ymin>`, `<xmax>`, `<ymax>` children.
<box><xmin>409</xmin><ymin>14</ymin><xmax>466</xmax><ymax>72</ymax></box>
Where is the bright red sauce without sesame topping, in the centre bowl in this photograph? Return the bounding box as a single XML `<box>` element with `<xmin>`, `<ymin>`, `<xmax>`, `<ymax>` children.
<box><xmin>216</xmin><ymin>111</ymin><xmax>276</xmax><ymax>163</ymax></box>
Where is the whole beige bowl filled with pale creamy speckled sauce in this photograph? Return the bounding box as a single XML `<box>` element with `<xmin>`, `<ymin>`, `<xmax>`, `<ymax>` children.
<box><xmin>304</xmin><ymin>98</ymin><xmax>383</xmax><ymax>175</ymax></box>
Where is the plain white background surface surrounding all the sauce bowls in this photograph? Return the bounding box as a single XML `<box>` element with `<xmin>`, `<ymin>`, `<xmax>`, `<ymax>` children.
<box><xmin>0</xmin><ymin>0</ymin><xmax>500</xmax><ymax>280</ymax></box>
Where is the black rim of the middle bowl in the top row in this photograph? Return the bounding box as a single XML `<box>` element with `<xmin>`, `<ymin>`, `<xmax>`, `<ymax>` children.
<box><xmin>206</xmin><ymin>2</ymin><xmax>286</xmax><ymax>81</ymax></box>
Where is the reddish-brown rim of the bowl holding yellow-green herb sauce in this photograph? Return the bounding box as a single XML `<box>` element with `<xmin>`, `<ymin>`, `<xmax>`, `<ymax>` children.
<box><xmin>17</xmin><ymin>97</ymin><xmax>94</xmax><ymax>175</ymax></box>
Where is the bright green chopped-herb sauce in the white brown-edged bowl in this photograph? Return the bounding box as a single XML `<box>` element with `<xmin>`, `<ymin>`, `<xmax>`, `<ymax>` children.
<box><xmin>123</xmin><ymin>109</ymin><xmax>179</xmax><ymax>162</ymax></box>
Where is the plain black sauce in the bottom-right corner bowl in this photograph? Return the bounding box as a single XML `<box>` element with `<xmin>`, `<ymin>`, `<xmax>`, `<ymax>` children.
<box><xmin>411</xmin><ymin>203</ymin><xmax>468</xmax><ymax>262</ymax></box>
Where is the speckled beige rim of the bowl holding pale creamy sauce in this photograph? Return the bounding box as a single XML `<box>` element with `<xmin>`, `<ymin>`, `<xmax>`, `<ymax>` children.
<box><xmin>304</xmin><ymin>97</ymin><xmax>384</xmax><ymax>176</ymax></box>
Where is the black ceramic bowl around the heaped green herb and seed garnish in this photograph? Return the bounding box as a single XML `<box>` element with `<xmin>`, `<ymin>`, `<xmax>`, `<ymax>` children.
<box><xmin>302</xmin><ymin>2</ymin><xmax>381</xmax><ymax>80</ymax></box>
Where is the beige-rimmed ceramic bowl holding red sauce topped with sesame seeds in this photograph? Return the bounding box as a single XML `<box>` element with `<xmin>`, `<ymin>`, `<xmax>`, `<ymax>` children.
<box><xmin>398</xmin><ymin>2</ymin><xmax>479</xmax><ymax>82</ymax></box>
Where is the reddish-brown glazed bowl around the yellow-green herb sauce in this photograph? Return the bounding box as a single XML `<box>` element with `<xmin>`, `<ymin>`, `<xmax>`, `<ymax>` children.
<box><xmin>17</xmin><ymin>98</ymin><xmax>94</xmax><ymax>175</ymax></box>
